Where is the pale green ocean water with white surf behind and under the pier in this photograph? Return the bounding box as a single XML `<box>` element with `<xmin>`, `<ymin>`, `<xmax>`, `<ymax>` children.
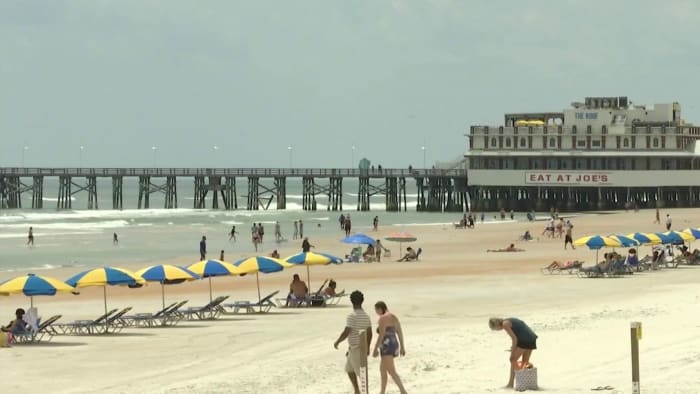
<box><xmin>0</xmin><ymin>178</ymin><xmax>482</xmax><ymax>272</ymax></box>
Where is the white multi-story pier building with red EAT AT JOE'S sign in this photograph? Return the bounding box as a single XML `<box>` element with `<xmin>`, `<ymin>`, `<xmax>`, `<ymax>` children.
<box><xmin>466</xmin><ymin>97</ymin><xmax>700</xmax><ymax>210</ymax></box>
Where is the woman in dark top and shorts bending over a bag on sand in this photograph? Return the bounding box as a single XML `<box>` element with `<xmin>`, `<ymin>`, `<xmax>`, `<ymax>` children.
<box><xmin>489</xmin><ymin>317</ymin><xmax>537</xmax><ymax>388</ymax></box>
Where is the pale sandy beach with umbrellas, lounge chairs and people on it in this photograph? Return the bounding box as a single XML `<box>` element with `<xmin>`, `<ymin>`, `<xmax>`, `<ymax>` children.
<box><xmin>0</xmin><ymin>209</ymin><xmax>700</xmax><ymax>393</ymax></box>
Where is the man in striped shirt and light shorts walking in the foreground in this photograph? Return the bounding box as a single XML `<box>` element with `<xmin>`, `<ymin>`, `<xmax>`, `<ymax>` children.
<box><xmin>333</xmin><ymin>290</ymin><xmax>372</xmax><ymax>394</ymax></box>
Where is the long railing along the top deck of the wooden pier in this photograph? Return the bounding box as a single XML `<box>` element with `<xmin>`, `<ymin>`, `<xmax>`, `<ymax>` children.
<box><xmin>0</xmin><ymin>167</ymin><xmax>467</xmax><ymax>178</ymax></box>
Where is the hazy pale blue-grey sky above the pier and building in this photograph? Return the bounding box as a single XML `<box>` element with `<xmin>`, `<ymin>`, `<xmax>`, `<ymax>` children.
<box><xmin>0</xmin><ymin>0</ymin><xmax>700</xmax><ymax>168</ymax></box>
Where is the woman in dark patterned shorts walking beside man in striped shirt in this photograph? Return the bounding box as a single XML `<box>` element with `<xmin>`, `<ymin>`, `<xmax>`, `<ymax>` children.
<box><xmin>372</xmin><ymin>301</ymin><xmax>406</xmax><ymax>394</ymax></box>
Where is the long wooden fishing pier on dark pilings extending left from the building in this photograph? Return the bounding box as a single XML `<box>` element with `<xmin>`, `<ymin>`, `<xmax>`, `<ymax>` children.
<box><xmin>0</xmin><ymin>168</ymin><xmax>468</xmax><ymax>212</ymax></box>
